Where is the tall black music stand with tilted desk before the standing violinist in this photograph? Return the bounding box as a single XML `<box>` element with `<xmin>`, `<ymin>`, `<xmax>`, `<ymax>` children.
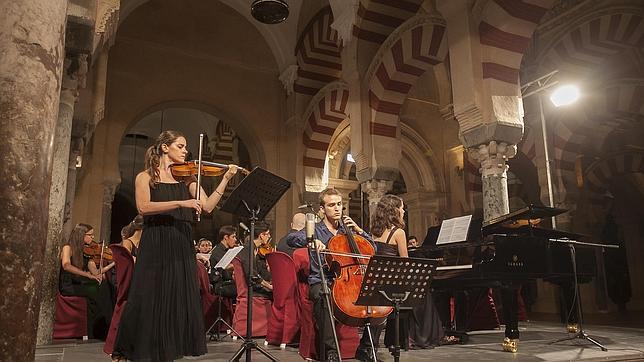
<box><xmin>221</xmin><ymin>167</ymin><xmax>291</xmax><ymax>362</ymax></box>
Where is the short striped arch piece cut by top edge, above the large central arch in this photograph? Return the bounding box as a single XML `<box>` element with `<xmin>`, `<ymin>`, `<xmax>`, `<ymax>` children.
<box><xmin>353</xmin><ymin>0</ymin><xmax>423</xmax><ymax>44</ymax></box>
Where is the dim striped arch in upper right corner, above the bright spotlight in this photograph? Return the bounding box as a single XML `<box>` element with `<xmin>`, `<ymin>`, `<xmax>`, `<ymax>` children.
<box><xmin>540</xmin><ymin>9</ymin><xmax>644</xmax><ymax>76</ymax></box>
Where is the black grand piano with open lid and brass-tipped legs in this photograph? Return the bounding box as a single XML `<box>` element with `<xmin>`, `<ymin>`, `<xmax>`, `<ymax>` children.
<box><xmin>410</xmin><ymin>205</ymin><xmax>596</xmax><ymax>352</ymax></box>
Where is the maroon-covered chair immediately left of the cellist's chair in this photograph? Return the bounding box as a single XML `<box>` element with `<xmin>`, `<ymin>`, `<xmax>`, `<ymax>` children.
<box><xmin>266</xmin><ymin>251</ymin><xmax>300</xmax><ymax>349</ymax></box>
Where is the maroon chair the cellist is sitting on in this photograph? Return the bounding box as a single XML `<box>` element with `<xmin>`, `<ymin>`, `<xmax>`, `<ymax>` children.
<box><xmin>293</xmin><ymin>248</ymin><xmax>360</xmax><ymax>359</ymax></box>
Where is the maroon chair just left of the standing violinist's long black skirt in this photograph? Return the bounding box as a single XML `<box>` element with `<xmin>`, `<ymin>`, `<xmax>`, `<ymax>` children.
<box><xmin>103</xmin><ymin>244</ymin><xmax>134</xmax><ymax>354</ymax></box>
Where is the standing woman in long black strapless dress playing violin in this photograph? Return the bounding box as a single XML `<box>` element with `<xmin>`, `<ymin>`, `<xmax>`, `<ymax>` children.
<box><xmin>114</xmin><ymin>131</ymin><xmax>237</xmax><ymax>361</ymax></box>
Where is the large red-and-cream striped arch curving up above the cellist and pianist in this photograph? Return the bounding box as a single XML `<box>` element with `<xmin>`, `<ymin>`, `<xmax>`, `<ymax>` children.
<box><xmin>365</xmin><ymin>15</ymin><xmax>448</xmax><ymax>138</ymax></box>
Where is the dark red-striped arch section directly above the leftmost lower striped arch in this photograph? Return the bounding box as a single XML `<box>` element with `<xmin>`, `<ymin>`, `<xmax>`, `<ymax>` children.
<box><xmin>293</xmin><ymin>6</ymin><xmax>342</xmax><ymax>96</ymax></box>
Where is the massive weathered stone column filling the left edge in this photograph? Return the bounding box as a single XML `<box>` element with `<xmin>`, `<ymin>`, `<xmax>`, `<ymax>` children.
<box><xmin>0</xmin><ymin>0</ymin><xmax>67</xmax><ymax>361</ymax></box>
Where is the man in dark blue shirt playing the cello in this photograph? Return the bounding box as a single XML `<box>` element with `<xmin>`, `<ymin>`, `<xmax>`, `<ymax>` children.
<box><xmin>289</xmin><ymin>188</ymin><xmax>375</xmax><ymax>361</ymax></box>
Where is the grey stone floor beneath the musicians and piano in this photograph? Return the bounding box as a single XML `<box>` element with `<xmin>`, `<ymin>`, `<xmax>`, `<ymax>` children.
<box><xmin>36</xmin><ymin>322</ymin><xmax>644</xmax><ymax>362</ymax></box>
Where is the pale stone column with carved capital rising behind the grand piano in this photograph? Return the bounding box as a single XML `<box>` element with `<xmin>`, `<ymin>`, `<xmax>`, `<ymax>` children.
<box><xmin>469</xmin><ymin>141</ymin><xmax>517</xmax><ymax>221</ymax></box>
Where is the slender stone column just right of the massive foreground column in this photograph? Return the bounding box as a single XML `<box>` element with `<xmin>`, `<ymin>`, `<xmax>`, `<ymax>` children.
<box><xmin>37</xmin><ymin>55</ymin><xmax>87</xmax><ymax>345</ymax></box>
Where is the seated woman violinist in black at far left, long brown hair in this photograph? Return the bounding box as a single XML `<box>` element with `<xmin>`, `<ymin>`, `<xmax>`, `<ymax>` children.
<box><xmin>58</xmin><ymin>224</ymin><xmax>114</xmax><ymax>338</ymax></box>
